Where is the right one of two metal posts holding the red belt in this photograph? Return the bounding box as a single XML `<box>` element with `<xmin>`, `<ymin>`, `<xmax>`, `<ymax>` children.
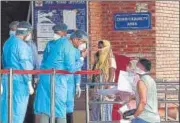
<box><xmin>50</xmin><ymin>69</ymin><xmax>56</xmax><ymax>123</ymax></box>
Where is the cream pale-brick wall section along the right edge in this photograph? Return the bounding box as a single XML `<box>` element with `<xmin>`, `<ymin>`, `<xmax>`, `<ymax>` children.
<box><xmin>155</xmin><ymin>1</ymin><xmax>180</xmax><ymax>80</ymax></box>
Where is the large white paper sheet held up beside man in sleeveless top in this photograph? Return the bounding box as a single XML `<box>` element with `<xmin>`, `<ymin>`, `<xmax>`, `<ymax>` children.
<box><xmin>118</xmin><ymin>71</ymin><xmax>134</xmax><ymax>93</ymax></box>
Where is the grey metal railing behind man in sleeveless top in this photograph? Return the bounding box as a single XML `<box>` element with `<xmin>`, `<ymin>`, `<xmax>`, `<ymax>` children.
<box><xmin>85</xmin><ymin>81</ymin><xmax>179</xmax><ymax>123</ymax></box>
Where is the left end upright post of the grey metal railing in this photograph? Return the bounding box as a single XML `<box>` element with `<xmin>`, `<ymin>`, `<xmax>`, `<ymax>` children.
<box><xmin>86</xmin><ymin>84</ymin><xmax>90</xmax><ymax>123</ymax></box>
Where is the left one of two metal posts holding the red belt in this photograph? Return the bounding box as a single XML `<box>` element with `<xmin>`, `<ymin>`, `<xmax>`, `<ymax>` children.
<box><xmin>8</xmin><ymin>68</ymin><xmax>13</xmax><ymax>123</ymax></box>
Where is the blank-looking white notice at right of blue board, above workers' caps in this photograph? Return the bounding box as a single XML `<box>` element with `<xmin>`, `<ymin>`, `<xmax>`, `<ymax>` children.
<box><xmin>63</xmin><ymin>10</ymin><xmax>76</xmax><ymax>30</ymax></box>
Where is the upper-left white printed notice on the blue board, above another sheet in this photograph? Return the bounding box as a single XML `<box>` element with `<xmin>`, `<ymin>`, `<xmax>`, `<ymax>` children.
<box><xmin>37</xmin><ymin>23</ymin><xmax>54</xmax><ymax>38</ymax></box>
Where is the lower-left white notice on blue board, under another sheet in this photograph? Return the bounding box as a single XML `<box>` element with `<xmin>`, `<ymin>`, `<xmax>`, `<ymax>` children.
<box><xmin>37</xmin><ymin>38</ymin><xmax>52</xmax><ymax>51</ymax></box>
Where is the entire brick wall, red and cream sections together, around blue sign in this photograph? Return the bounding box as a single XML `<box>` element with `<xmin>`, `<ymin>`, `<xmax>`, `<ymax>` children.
<box><xmin>89</xmin><ymin>1</ymin><xmax>179</xmax><ymax>80</ymax></box>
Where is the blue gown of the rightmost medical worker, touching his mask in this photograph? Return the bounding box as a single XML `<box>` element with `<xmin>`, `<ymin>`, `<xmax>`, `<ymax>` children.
<box><xmin>66</xmin><ymin>48</ymin><xmax>81</xmax><ymax>113</ymax></box>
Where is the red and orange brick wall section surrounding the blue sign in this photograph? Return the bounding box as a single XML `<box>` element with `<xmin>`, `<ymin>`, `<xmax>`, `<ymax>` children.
<box><xmin>89</xmin><ymin>1</ymin><xmax>156</xmax><ymax>75</ymax></box>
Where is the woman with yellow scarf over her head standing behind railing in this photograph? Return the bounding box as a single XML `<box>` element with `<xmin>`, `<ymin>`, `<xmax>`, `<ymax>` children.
<box><xmin>91</xmin><ymin>40</ymin><xmax>116</xmax><ymax>121</ymax></box>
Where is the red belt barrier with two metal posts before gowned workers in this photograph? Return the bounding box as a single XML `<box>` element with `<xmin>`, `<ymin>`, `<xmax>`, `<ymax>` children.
<box><xmin>0</xmin><ymin>69</ymin><xmax>100</xmax><ymax>123</ymax></box>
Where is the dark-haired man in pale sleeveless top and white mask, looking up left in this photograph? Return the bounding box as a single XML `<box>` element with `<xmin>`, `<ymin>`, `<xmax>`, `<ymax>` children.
<box><xmin>123</xmin><ymin>58</ymin><xmax>160</xmax><ymax>123</ymax></box>
